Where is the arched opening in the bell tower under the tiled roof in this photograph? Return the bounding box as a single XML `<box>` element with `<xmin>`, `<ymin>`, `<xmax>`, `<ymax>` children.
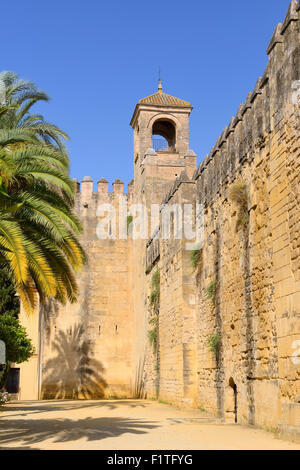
<box><xmin>152</xmin><ymin>119</ymin><xmax>176</xmax><ymax>152</ymax></box>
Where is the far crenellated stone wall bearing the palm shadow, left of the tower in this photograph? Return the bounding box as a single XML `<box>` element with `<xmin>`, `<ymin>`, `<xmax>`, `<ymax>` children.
<box><xmin>40</xmin><ymin>177</ymin><xmax>133</xmax><ymax>399</ymax></box>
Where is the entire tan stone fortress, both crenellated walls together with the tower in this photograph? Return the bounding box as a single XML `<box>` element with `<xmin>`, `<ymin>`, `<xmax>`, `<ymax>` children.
<box><xmin>21</xmin><ymin>0</ymin><xmax>300</xmax><ymax>437</ymax></box>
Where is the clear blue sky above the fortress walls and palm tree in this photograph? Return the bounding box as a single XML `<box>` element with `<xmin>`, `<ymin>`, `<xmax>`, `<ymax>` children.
<box><xmin>0</xmin><ymin>0</ymin><xmax>290</xmax><ymax>191</ymax></box>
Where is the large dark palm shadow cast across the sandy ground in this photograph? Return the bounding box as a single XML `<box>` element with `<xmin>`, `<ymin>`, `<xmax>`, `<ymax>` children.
<box><xmin>0</xmin><ymin>417</ymin><xmax>158</xmax><ymax>449</ymax></box>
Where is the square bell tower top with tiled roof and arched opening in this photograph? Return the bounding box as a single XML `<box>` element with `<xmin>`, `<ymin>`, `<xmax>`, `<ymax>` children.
<box><xmin>130</xmin><ymin>79</ymin><xmax>196</xmax><ymax>203</ymax></box>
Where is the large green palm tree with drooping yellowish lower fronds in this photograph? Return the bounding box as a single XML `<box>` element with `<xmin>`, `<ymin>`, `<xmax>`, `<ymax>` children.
<box><xmin>0</xmin><ymin>72</ymin><xmax>85</xmax><ymax>312</ymax></box>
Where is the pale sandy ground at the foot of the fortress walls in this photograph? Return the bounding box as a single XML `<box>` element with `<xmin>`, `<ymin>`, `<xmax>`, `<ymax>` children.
<box><xmin>0</xmin><ymin>400</ymin><xmax>300</xmax><ymax>450</ymax></box>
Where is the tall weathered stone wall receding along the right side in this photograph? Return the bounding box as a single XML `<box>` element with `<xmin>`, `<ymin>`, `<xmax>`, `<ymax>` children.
<box><xmin>145</xmin><ymin>2</ymin><xmax>300</xmax><ymax>435</ymax></box>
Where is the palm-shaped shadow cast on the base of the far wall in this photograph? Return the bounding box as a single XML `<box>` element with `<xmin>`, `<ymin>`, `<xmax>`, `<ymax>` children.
<box><xmin>42</xmin><ymin>324</ymin><xmax>107</xmax><ymax>399</ymax></box>
